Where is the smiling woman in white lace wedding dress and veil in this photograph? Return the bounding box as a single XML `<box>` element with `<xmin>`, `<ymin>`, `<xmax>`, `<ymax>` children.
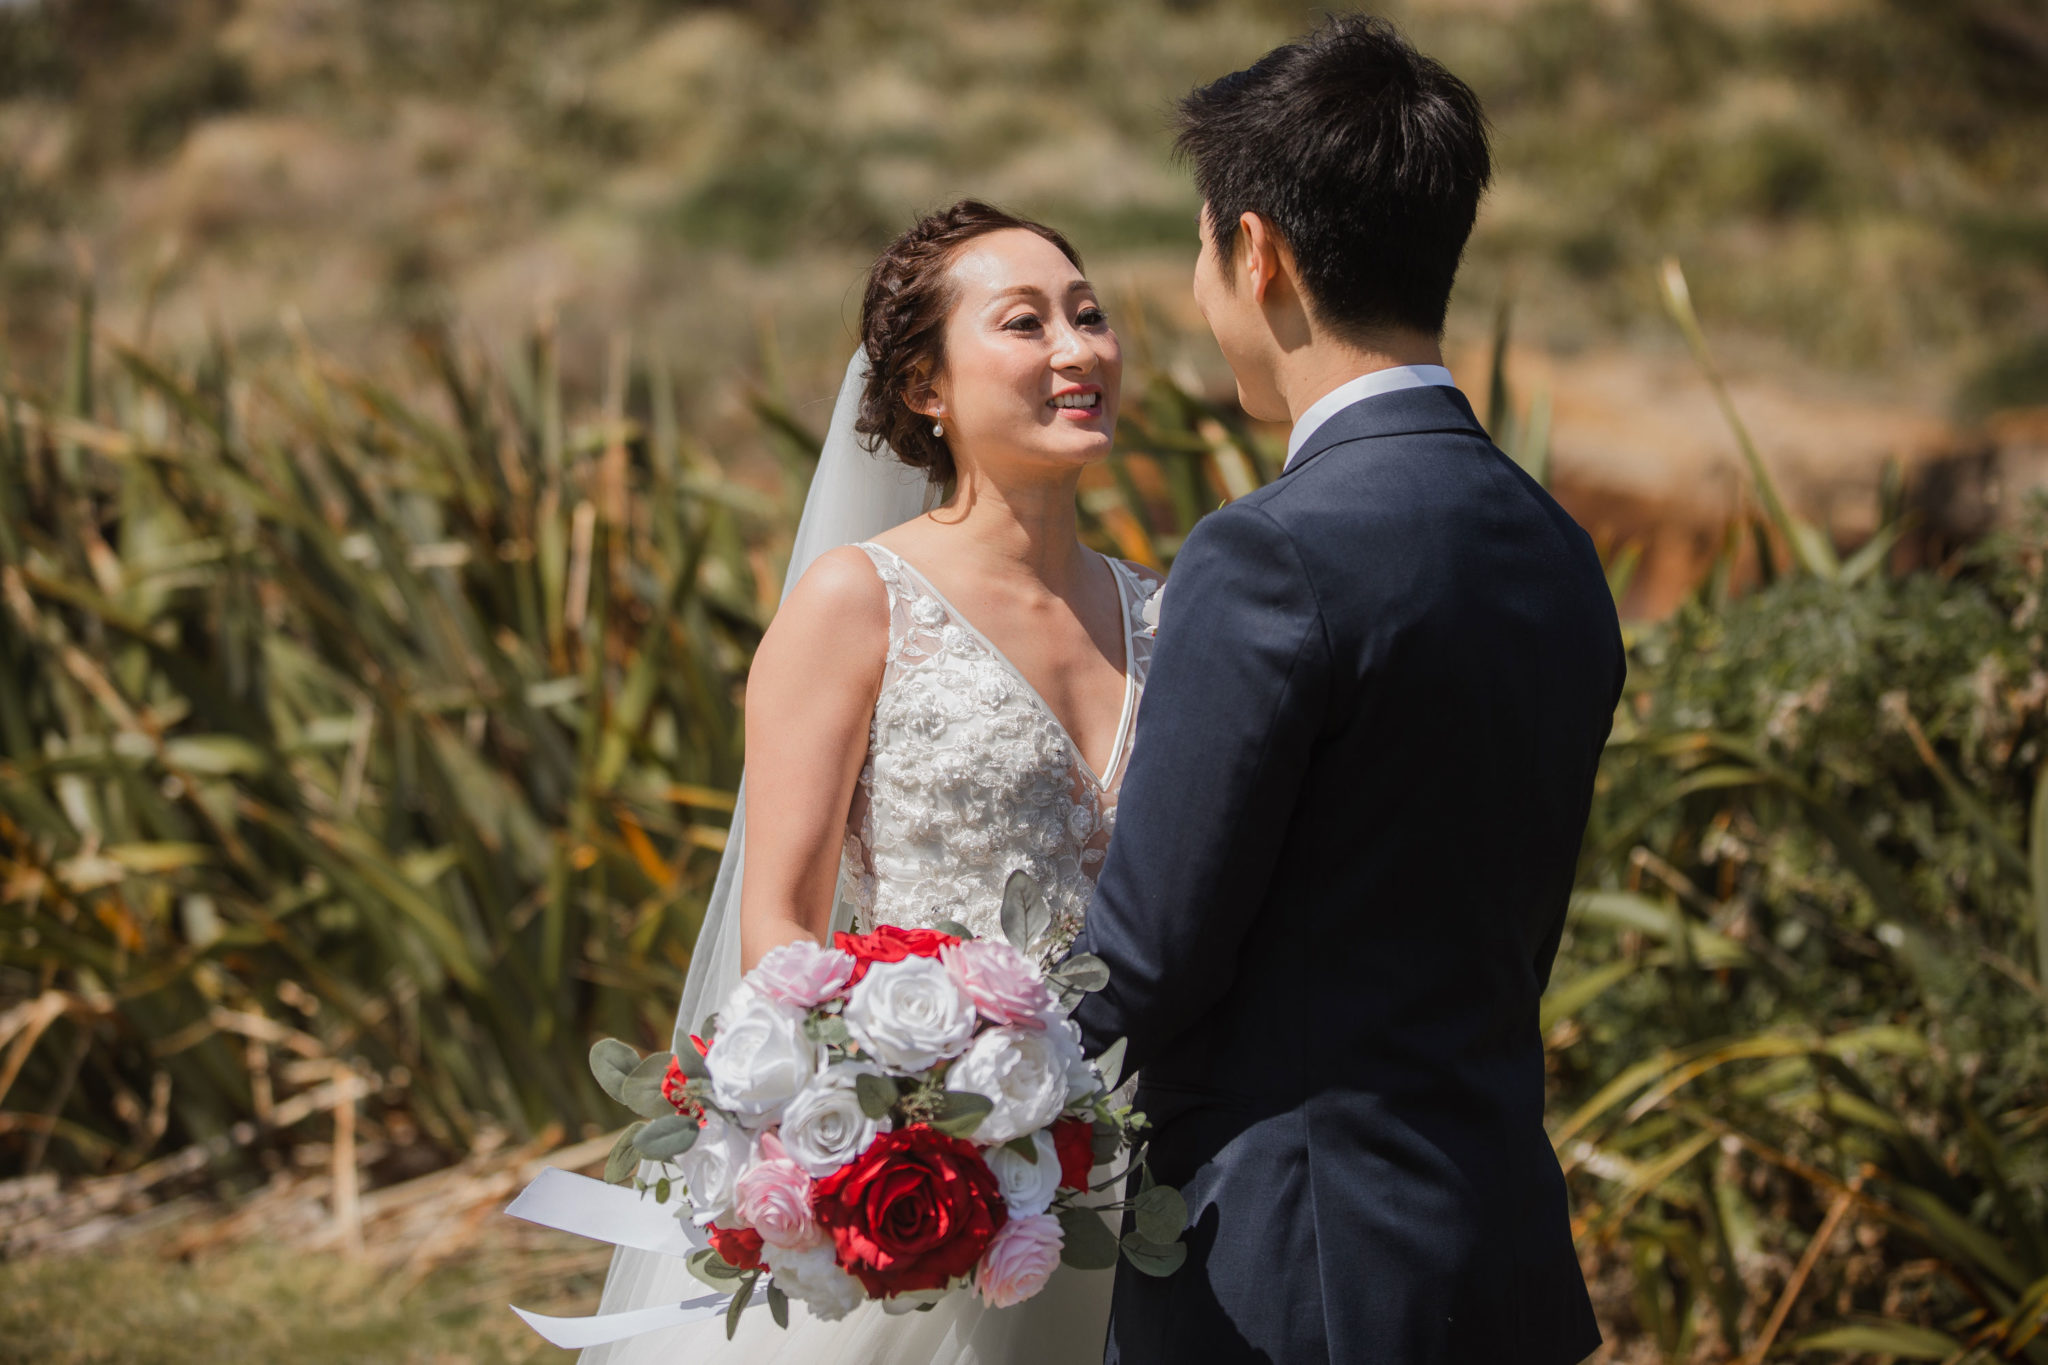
<box><xmin>584</xmin><ymin>201</ymin><xmax>1159</xmax><ymax>1365</ymax></box>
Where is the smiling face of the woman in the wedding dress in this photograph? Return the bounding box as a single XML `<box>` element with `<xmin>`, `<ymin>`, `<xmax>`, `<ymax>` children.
<box><xmin>934</xmin><ymin>227</ymin><xmax>1124</xmax><ymax>485</ymax></box>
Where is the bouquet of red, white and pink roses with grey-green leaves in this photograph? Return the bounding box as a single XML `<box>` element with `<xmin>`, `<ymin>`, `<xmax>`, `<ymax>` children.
<box><xmin>590</xmin><ymin>872</ymin><xmax>1188</xmax><ymax>1334</ymax></box>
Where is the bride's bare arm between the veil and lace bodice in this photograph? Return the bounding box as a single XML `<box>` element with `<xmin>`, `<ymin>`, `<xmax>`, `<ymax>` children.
<box><xmin>739</xmin><ymin>546</ymin><xmax>889</xmax><ymax>970</ymax></box>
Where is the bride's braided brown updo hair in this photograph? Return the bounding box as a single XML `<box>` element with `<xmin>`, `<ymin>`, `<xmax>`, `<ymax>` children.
<box><xmin>854</xmin><ymin>199</ymin><xmax>1081</xmax><ymax>483</ymax></box>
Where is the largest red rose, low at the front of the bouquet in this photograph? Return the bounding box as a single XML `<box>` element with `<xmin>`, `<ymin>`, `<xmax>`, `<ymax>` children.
<box><xmin>811</xmin><ymin>1124</ymin><xmax>1010</xmax><ymax>1297</ymax></box>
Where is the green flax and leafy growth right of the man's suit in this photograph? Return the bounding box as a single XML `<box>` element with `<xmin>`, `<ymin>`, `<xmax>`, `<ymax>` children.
<box><xmin>1542</xmin><ymin>264</ymin><xmax>2048</xmax><ymax>1363</ymax></box>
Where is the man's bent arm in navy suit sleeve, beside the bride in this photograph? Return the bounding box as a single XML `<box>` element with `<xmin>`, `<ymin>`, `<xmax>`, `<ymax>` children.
<box><xmin>1073</xmin><ymin>505</ymin><xmax>1331</xmax><ymax>1074</ymax></box>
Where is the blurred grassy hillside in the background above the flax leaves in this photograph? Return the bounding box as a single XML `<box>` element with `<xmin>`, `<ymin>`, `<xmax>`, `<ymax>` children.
<box><xmin>0</xmin><ymin>0</ymin><xmax>2048</xmax><ymax>417</ymax></box>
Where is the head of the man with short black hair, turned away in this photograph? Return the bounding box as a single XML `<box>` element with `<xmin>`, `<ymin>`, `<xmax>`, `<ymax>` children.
<box><xmin>1180</xmin><ymin>14</ymin><xmax>1491</xmax><ymax>415</ymax></box>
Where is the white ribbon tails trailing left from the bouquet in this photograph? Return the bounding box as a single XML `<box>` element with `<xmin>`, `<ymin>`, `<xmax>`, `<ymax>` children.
<box><xmin>506</xmin><ymin>1166</ymin><xmax>768</xmax><ymax>1351</ymax></box>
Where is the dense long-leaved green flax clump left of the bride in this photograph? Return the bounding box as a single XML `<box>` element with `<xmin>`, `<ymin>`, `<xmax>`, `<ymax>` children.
<box><xmin>0</xmin><ymin>298</ymin><xmax>778</xmax><ymax>1171</ymax></box>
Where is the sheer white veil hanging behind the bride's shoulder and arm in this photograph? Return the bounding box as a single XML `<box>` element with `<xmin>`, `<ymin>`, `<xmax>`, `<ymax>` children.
<box><xmin>582</xmin><ymin>350</ymin><xmax>932</xmax><ymax>1365</ymax></box>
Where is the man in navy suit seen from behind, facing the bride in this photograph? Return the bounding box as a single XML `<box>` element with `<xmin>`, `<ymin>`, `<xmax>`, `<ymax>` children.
<box><xmin>1075</xmin><ymin>16</ymin><xmax>1624</xmax><ymax>1365</ymax></box>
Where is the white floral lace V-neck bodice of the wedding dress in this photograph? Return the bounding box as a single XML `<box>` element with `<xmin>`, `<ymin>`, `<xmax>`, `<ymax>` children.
<box><xmin>840</xmin><ymin>544</ymin><xmax>1159</xmax><ymax>945</ymax></box>
